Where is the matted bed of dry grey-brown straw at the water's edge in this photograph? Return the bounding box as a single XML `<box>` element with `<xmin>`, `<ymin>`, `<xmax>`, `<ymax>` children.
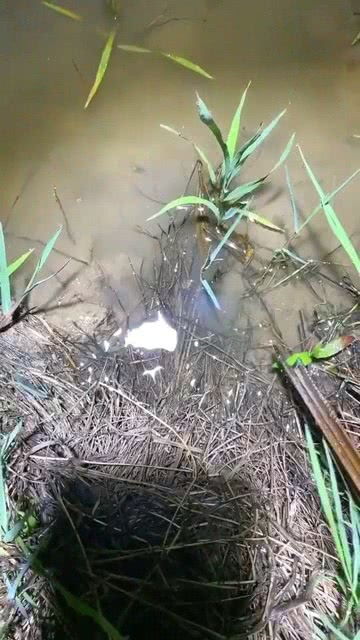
<box><xmin>0</xmin><ymin>221</ymin><xmax>352</xmax><ymax>640</ymax></box>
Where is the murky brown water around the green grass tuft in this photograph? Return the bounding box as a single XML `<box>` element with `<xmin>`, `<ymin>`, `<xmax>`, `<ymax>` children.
<box><xmin>0</xmin><ymin>0</ymin><xmax>360</xmax><ymax>348</ymax></box>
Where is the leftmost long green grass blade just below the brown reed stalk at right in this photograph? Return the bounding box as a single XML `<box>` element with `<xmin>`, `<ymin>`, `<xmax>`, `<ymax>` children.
<box><xmin>305</xmin><ymin>425</ymin><xmax>351</xmax><ymax>580</ymax></box>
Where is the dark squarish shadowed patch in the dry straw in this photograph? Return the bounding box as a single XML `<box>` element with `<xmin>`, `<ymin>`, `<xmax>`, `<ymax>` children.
<box><xmin>39</xmin><ymin>479</ymin><xmax>264</xmax><ymax>640</ymax></box>
